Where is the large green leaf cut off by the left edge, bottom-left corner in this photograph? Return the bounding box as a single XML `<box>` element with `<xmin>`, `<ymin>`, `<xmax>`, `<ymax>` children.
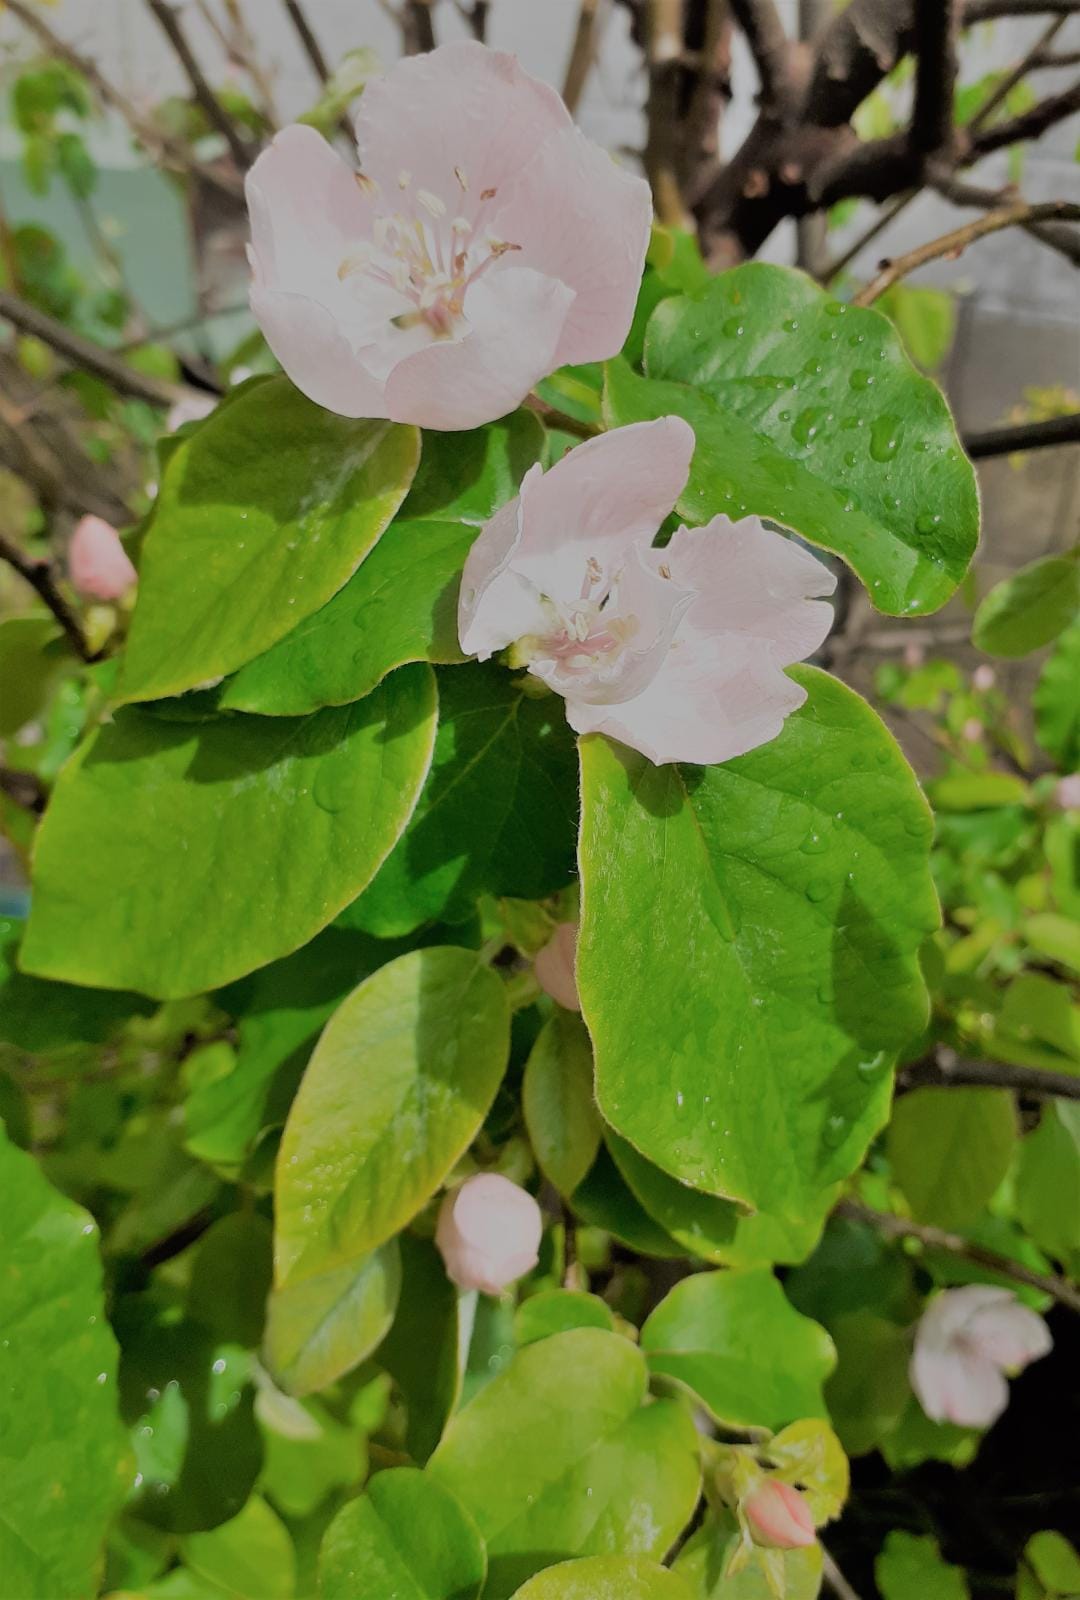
<box><xmin>0</xmin><ymin>1128</ymin><xmax>131</xmax><ymax>1600</ymax></box>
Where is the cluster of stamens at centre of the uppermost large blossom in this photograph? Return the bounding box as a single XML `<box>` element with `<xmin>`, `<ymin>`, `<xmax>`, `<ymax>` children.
<box><xmin>338</xmin><ymin>166</ymin><xmax>522</xmax><ymax>339</ymax></box>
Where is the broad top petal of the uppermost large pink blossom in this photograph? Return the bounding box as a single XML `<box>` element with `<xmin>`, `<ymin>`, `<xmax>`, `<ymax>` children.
<box><xmin>357</xmin><ymin>40</ymin><xmax>570</xmax><ymax>218</ymax></box>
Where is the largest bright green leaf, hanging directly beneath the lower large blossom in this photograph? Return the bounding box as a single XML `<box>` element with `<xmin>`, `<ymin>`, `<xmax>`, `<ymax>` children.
<box><xmin>578</xmin><ymin>667</ymin><xmax>939</xmax><ymax>1224</ymax></box>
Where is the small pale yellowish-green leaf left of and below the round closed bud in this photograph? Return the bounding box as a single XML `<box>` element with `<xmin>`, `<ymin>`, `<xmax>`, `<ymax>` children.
<box><xmin>264</xmin><ymin>1240</ymin><xmax>402</xmax><ymax>1395</ymax></box>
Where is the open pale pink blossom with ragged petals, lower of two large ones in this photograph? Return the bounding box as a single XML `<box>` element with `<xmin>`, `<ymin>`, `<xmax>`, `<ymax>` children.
<box><xmin>458</xmin><ymin>416</ymin><xmax>835</xmax><ymax>763</ymax></box>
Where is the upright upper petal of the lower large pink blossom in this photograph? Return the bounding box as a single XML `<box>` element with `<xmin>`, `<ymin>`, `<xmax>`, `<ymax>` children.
<box><xmin>512</xmin><ymin>416</ymin><xmax>694</xmax><ymax>603</ymax></box>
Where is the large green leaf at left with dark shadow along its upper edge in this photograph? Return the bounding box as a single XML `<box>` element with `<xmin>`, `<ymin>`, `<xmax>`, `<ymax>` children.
<box><xmin>21</xmin><ymin>666</ymin><xmax>435</xmax><ymax>998</ymax></box>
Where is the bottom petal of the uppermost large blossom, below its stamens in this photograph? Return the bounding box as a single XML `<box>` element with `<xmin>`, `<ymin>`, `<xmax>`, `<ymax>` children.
<box><xmin>386</xmin><ymin>267</ymin><xmax>573</xmax><ymax>429</ymax></box>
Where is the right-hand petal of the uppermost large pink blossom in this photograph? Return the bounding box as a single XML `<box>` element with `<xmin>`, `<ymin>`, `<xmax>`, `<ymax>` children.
<box><xmin>491</xmin><ymin>128</ymin><xmax>653</xmax><ymax>366</ymax></box>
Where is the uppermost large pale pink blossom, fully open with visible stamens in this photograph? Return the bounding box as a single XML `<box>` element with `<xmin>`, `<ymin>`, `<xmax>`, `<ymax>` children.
<box><xmin>246</xmin><ymin>42</ymin><xmax>651</xmax><ymax>429</ymax></box>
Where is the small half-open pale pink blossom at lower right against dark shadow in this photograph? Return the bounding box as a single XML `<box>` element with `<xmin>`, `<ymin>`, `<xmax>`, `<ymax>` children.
<box><xmin>910</xmin><ymin>1283</ymin><xmax>1053</xmax><ymax>1427</ymax></box>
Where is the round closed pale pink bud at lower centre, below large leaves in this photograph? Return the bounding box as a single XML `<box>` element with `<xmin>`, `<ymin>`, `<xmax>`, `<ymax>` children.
<box><xmin>435</xmin><ymin>1173</ymin><xmax>542</xmax><ymax>1294</ymax></box>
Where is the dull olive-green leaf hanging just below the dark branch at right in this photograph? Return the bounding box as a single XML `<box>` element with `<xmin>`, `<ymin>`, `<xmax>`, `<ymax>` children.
<box><xmin>888</xmin><ymin>1088</ymin><xmax>1016</xmax><ymax>1227</ymax></box>
